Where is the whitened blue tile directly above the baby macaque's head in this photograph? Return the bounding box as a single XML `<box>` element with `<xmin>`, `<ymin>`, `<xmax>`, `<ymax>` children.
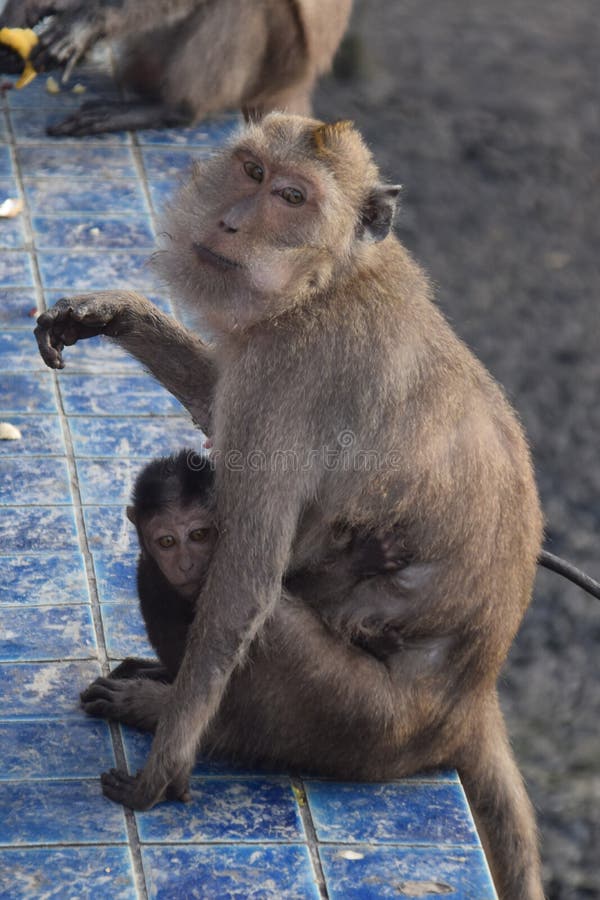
<box><xmin>69</xmin><ymin>416</ymin><xmax>204</xmax><ymax>458</ymax></box>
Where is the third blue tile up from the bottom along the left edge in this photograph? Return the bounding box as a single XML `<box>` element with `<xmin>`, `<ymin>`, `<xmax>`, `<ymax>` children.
<box><xmin>0</xmin><ymin>713</ymin><xmax>115</xmax><ymax>781</ymax></box>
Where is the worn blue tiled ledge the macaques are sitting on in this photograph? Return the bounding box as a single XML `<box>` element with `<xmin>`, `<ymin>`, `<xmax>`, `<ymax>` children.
<box><xmin>0</xmin><ymin>51</ymin><xmax>495</xmax><ymax>900</ymax></box>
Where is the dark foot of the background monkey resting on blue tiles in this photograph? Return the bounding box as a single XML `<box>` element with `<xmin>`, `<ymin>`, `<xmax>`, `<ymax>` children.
<box><xmin>47</xmin><ymin>100</ymin><xmax>191</xmax><ymax>137</ymax></box>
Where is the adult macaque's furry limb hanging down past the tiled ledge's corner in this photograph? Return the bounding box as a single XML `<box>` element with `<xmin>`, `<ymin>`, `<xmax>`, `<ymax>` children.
<box><xmin>458</xmin><ymin>695</ymin><xmax>544</xmax><ymax>900</ymax></box>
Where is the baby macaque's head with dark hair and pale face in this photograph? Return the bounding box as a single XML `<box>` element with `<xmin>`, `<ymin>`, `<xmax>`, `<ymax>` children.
<box><xmin>127</xmin><ymin>450</ymin><xmax>217</xmax><ymax>596</ymax></box>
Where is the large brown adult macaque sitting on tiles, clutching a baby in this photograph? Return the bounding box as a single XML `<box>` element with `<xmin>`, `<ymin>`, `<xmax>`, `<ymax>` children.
<box><xmin>37</xmin><ymin>113</ymin><xmax>543</xmax><ymax>900</ymax></box>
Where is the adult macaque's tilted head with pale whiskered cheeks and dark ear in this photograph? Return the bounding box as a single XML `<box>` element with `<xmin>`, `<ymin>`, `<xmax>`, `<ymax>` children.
<box><xmin>157</xmin><ymin>113</ymin><xmax>399</xmax><ymax>331</ymax></box>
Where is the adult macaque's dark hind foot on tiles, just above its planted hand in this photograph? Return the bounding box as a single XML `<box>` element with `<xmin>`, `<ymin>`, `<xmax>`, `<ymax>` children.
<box><xmin>81</xmin><ymin>677</ymin><xmax>171</xmax><ymax>731</ymax></box>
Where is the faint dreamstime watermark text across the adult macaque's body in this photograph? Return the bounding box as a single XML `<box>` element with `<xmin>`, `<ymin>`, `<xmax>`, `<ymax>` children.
<box><xmin>187</xmin><ymin>428</ymin><xmax>402</xmax><ymax>474</ymax></box>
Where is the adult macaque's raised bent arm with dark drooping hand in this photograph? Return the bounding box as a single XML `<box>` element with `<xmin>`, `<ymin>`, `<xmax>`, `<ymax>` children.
<box><xmin>35</xmin><ymin>291</ymin><xmax>217</xmax><ymax>431</ymax></box>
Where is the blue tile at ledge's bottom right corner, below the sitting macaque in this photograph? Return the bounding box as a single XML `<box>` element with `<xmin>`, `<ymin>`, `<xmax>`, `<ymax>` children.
<box><xmin>319</xmin><ymin>844</ymin><xmax>496</xmax><ymax>900</ymax></box>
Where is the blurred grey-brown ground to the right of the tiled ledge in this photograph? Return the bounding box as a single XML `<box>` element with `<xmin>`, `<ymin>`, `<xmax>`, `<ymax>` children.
<box><xmin>316</xmin><ymin>0</ymin><xmax>600</xmax><ymax>900</ymax></box>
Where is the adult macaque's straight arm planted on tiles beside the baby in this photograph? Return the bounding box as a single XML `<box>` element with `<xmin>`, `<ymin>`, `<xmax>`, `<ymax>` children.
<box><xmin>103</xmin><ymin>418</ymin><xmax>310</xmax><ymax>809</ymax></box>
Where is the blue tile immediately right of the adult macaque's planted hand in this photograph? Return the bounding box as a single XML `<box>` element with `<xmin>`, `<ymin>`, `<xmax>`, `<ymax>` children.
<box><xmin>136</xmin><ymin>778</ymin><xmax>305</xmax><ymax>844</ymax></box>
